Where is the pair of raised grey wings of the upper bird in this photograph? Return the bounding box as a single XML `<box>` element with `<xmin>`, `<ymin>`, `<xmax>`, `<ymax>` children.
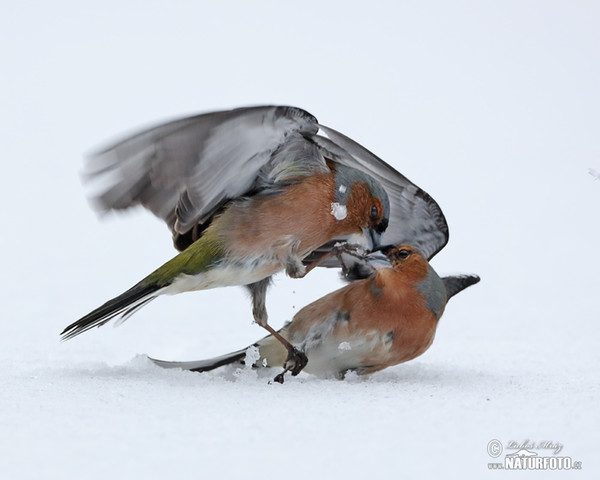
<box><xmin>86</xmin><ymin>106</ymin><xmax>448</xmax><ymax>258</ymax></box>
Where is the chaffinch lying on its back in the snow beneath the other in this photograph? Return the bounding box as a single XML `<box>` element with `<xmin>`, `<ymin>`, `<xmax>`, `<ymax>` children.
<box><xmin>152</xmin><ymin>245</ymin><xmax>479</xmax><ymax>383</ymax></box>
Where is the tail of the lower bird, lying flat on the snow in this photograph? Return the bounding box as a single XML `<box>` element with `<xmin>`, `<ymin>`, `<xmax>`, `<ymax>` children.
<box><xmin>148</xmin><ymin>330</ymin><xmax>287</xmax><ymax>372</ymax></box>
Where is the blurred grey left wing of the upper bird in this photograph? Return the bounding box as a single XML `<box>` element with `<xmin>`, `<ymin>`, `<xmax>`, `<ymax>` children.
<box><xmin>86</xmin><ymin>107</ymin><xmax>318</xmax><ymax>233</ymax></box>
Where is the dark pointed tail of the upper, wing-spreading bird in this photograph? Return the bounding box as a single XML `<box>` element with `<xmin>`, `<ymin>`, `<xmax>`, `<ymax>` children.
<box><xmin>60</xmin><ymin>283</ymin><xmax>164</xmax><ymax>340</ymax></box>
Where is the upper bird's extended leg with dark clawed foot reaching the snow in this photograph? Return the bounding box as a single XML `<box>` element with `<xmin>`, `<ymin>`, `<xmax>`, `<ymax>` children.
<box><xmin>247</xmin><ymin>277</ymin><xmax>308</xmax><ymax>383</ymax></box>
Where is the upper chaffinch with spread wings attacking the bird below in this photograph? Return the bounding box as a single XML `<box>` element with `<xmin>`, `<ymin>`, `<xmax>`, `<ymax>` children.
<box><xmin>62</xmin><ymin>107</ymin><xmax>448</xmax><ymax>369</ymax></box>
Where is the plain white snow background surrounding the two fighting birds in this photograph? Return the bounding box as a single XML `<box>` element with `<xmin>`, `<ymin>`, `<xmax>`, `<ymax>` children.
<box><xmin>0</xmin><ymin>0</ymin><xmax>600</xmax><ymax>480</ymax></box>
